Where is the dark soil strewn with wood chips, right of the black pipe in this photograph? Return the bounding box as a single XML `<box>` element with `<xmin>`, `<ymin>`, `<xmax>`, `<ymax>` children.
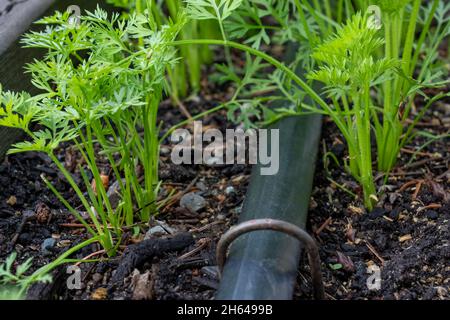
<box><xmin>296</xmin><ymin>95</ymin><xmax>450</xmax><ymax>300</ymax></box>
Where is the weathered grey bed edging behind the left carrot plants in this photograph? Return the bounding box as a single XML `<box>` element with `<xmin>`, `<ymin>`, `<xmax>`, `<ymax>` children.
<box><xmin>0</xmin><ymin>0</ymin><xmax>105</xmax><ymax>158</ymax></box>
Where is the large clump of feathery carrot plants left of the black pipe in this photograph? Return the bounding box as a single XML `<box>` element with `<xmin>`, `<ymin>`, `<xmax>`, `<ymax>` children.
<box><xmin>0</xmin><ymin>8</ymin><xmax>185</xmax><ymax>255</ymax></box>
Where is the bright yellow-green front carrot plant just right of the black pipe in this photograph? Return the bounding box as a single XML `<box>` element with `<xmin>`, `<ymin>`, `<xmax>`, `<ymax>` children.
<box><xmin>309</xmin><ymin>14</ymin><xmax>400</xmax><ymax>208</ymax></box>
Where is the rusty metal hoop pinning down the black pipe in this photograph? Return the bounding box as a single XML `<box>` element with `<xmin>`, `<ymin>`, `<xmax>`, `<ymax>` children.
<box><xmin>216</xmin><ymin>219</ymin><xmax>325</xmax><ymax>300</ymax></box>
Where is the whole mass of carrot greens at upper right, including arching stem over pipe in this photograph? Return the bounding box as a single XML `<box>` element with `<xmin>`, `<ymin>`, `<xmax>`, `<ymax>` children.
<box><xmin>182</xmin><ymin>0</ymin><xmax>450</xmax><ymax>208</ymax></box>
